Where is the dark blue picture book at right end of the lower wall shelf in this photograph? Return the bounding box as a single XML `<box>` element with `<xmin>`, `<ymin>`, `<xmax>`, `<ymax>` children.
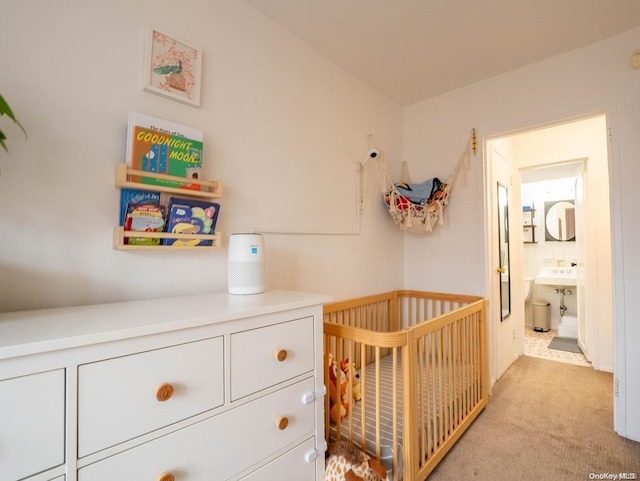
<box><xmin>163</xmin><ymin>197</ymin><xmax>220</xmax><ymax>246</ymax></box>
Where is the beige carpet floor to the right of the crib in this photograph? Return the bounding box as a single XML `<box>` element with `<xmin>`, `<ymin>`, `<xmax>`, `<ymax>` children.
<box><xmin>428</xmin><ymin>356</ymin><xmax>640</xmax><ymax>481</ymax></box>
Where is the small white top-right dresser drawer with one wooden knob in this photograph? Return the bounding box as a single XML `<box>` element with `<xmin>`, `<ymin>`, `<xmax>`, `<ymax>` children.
<box><xmin>231</xmin><ymin>317</ymin><xmax>314</xmax><ymax>400</ymax></box>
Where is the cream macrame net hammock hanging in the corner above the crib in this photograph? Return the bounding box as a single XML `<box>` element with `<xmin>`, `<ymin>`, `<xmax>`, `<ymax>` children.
<box><xmin>379</xmin><ymin>129</ymin><xmax>477</xmax><ymax>234</ymax></box>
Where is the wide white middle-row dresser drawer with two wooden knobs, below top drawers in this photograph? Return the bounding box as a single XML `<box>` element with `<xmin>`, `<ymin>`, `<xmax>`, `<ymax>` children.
<box><xmin>78</xmin><ymin>378</ymin><xmax>318</xmax><ymax>481</ymax></box>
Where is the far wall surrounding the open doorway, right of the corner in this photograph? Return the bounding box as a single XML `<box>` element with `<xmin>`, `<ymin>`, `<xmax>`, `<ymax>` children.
<box><xmin>404</xmin><ymin>28</ymin><xmax>640</xmax><ymax>440</ymax></box>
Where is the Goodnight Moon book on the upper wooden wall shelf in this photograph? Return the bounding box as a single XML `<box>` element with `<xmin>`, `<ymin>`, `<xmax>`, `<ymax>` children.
<box><xmin>126</xmin><ymin>112</ymin><xmax>204</xmax><ymax>190</ymax></box>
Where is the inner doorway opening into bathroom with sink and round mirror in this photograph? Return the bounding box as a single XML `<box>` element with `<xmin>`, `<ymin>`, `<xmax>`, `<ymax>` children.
<box><xmin>520</xmin><ymin>159</ymin><xmax>591</xmax><ymax>366</ymax></box>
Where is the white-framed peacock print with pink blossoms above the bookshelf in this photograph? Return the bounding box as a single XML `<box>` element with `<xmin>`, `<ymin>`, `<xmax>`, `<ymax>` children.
<box><xmin>143</xmin><ymin>27</ymin><xmax>202</xmax><ymax>107</ymax></box>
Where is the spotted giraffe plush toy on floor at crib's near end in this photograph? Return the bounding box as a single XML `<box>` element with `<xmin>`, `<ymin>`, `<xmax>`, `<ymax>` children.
<box><xmin>324</xmin><ymin>441</ymin><xmax>389</xmax><ymax>481</ymax></box>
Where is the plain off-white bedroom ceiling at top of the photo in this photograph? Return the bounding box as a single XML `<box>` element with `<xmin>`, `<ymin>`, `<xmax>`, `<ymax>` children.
<box><xmin>244</xmin><ymin>0</ymin><xmax>640</xmax><ymax>106</ymax></box>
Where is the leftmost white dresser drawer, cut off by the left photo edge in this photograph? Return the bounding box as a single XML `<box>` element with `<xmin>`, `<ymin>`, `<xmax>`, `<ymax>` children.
<box><xmin>0</xmin><ymin>369</ymin><xmax>65</xmax><ymax>481</ymax></box>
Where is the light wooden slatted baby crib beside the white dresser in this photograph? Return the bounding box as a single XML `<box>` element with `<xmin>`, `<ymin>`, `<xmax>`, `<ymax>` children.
<box><xmin>324</xmin><ymin>291</ymin><xmax>488</xmax><ymax>481</ymax></box>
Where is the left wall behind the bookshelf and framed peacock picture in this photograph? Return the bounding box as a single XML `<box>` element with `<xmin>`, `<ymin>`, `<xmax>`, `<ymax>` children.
<box><xmin>0</xmin><ymin>0</ymin><xmax>403</xmax><ymax>311</ymax></box>
